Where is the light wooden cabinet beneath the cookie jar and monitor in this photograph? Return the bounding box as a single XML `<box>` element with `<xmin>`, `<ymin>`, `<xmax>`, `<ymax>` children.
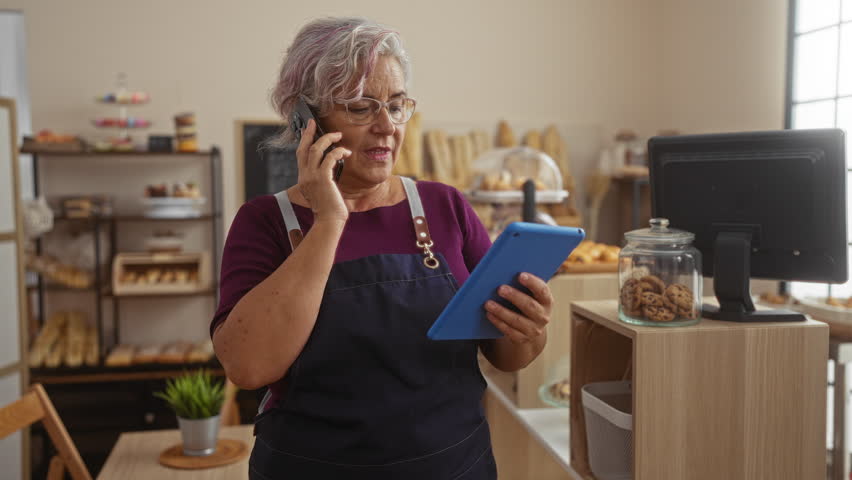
<box><xmin>570</xmin><ymin>300</ymin><xmax>828</xmax><ymax>480</ymax></box>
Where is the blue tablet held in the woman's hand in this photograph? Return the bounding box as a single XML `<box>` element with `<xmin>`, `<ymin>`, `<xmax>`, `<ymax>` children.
<box><xmin>427</xmin><ymin>222</ymin><xmax>586</xmax><ymax>340</ymax></box>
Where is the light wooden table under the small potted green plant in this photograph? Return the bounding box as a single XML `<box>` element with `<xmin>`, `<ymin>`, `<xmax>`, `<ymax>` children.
<box><xmin>98</xmin><ymin>425</ymin><xmax>254</xmax><ymax>480</ymax></box>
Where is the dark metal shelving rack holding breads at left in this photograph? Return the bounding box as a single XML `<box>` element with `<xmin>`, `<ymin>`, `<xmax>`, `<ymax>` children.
<box><xmin>21</xmin><ymin>147</ymin><xmax>223</xmax><ymax>377</ymax></box>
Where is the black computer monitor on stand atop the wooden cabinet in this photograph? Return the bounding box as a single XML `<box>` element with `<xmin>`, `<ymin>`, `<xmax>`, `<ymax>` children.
<box><xmin>648</xmin><ymin>129</ymin><xmax>848</xmax><ymax>322</ymax></box>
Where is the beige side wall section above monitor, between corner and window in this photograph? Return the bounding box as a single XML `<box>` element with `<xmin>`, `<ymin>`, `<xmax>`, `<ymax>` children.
<box><xmin>657</xmin><ymin>0</ymin><xmax>788</xmax><ymax>133</ymax></box>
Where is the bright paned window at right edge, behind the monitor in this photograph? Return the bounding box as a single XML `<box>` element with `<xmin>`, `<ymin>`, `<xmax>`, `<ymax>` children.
<box><xmin>786</xmin><ymin>0</ymin><xmax>852</xmax><ymax>298</ymax></box>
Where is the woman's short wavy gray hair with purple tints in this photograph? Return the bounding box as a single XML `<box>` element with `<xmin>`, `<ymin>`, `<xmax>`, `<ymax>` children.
<box><xmin>270</xmin><ymin>17</ymin><xmax>411</xmax><ymax>144</ymax></box>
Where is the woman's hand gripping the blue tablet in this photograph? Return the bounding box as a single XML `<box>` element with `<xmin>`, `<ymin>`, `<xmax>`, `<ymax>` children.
<box><xmin>485</xmin><ymin>273</ymin><xmax>553</xmax><ymax>344</ymax></box>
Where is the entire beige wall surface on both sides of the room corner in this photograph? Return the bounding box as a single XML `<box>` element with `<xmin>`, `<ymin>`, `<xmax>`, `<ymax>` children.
<box><xmin>0</xmin><ymin>0</ymin><xmax>787</xmax><ymax>342</ymax></box>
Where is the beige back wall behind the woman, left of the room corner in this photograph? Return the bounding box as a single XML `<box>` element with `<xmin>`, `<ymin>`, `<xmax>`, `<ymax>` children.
<box><xmin>0</xmin><ymin>0</ymin><xmax>659</xmax><ymax>228</ymax></box>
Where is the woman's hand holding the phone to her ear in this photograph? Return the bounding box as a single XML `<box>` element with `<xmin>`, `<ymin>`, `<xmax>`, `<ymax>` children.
<box><xmin>296</xmin><ymin>119</ymin><xmax>352</xmax><ymax>222</ymax></box>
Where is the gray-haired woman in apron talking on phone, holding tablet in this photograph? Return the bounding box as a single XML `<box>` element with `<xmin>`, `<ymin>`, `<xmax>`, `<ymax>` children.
<box><xmin>211</xmin><ymin>18</ymin><xmax>551</xmax><ymax>480</ymax></box>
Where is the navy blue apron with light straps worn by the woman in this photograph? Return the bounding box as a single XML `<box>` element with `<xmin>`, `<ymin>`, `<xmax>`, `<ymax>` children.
<box><xmin>249</xmin><ymin>178</ymin><xmax>497</xmax><ymax>480</ymax></box>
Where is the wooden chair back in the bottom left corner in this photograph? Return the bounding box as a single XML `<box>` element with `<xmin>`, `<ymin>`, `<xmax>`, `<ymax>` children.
<box><xmin>0</xmin><ymin>383</ymin><xmax>92</xmax><ymax>480</ymax></box>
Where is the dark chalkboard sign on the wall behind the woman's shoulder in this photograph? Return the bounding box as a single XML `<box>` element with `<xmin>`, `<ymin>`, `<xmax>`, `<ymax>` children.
<box><xmin>237</xmin><ymin>120</ymin><xmax>299</xmax><ymax>201</ymax></box>
